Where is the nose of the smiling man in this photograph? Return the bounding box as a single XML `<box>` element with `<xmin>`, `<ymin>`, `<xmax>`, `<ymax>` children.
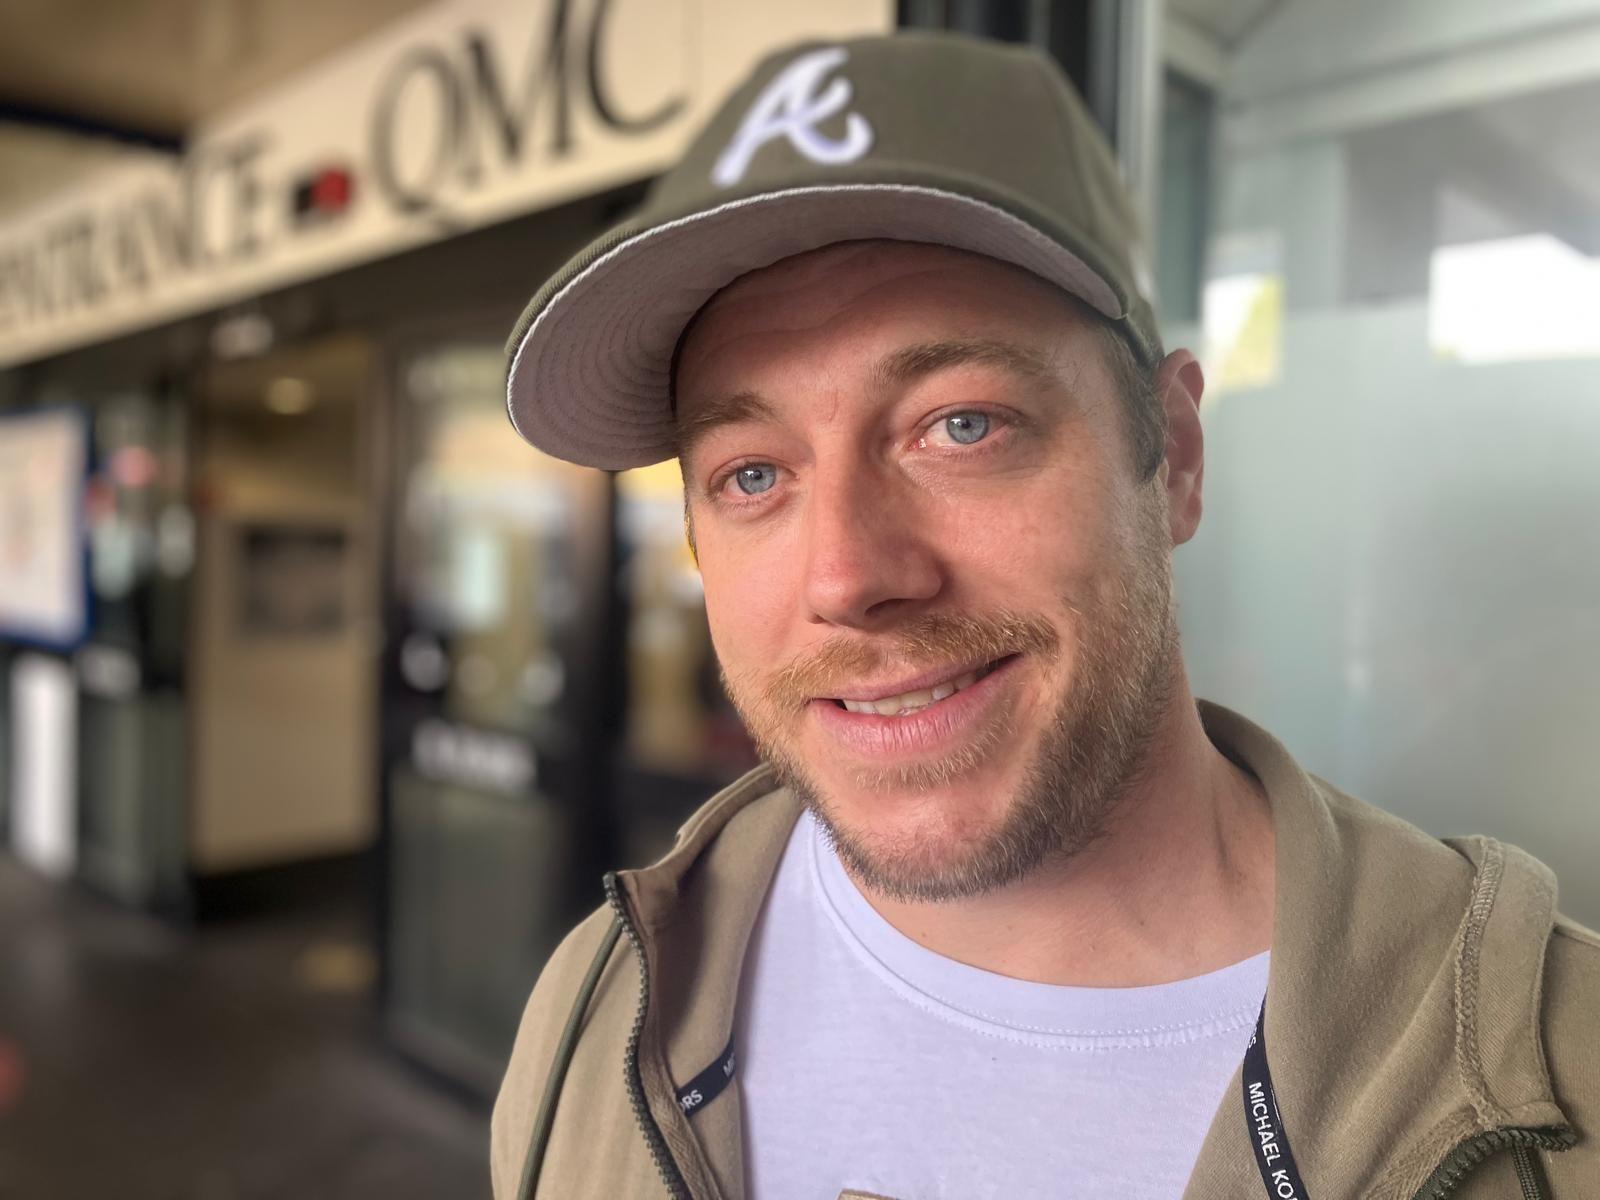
<box><xmin>803</xmin><ymin>459</ymin><xmax>944</xmax><ymax>629</ymax></box>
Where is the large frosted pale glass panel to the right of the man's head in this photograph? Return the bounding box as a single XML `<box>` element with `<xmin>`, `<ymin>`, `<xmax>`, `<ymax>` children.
<box><xmin>1168</xmin><ymin>35</ymin><xmax>1600</xmax><ymax>923</ymax></box>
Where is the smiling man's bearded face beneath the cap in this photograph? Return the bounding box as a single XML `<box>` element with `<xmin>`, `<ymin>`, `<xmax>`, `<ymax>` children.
<box><xmin>677</xmin><ymin>242</ymin><xmax>1178</xmax><ymax>899</ymax></box>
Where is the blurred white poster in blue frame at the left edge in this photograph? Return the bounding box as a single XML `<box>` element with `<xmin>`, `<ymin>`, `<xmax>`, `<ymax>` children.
<box><xmin>0</xmin><ymin>408</ymin><xmax>88</xmax><ymax>650</ymax></box>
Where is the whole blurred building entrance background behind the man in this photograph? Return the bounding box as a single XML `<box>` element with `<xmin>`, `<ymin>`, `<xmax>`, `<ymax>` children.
<box><xmin>0</xmin><ymin>0</ymin><xmax>1600</xmax><ymax>1200</ymax></box>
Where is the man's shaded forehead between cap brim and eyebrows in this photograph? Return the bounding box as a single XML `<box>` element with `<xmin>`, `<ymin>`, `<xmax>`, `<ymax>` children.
<box><xmin>675</xmin><ymin>242</ymin><xmax>1091</xmax><ymax>401</ymax></box>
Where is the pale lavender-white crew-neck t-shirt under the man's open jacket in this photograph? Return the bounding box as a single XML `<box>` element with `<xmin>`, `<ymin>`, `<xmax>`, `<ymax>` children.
<box><xmin>736</xmin><ymin>814</ymin><xmax>1267</xmax><ymax>1200</ymax></box>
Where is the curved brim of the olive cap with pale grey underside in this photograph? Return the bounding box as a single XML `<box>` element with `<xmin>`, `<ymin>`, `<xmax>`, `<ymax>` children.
<box><xmin>506</xmin><ymin>184</ymin><xmax>1123</xmax><ymax>470</ymax></box>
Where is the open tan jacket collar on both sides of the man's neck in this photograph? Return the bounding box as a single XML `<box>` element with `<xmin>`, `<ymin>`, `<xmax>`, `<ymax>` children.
<box><xmin>621</xmin><ymin>701</ymin><xmax>1568</xmax><ymax>1200</ymax></box>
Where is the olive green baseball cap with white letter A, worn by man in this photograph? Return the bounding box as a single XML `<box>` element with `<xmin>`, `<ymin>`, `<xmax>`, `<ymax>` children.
<box><xmin>506</xmin><ymin>32</ymin><xmax>1160</xmax><ymax>470</ymax></box>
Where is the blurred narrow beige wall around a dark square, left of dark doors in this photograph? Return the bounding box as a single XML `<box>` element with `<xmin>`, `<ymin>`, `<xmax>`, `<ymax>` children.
<box><xmin>190</xmin><ymin>344</ymin><xmax>378</xmax><ymax>874</ymax></box>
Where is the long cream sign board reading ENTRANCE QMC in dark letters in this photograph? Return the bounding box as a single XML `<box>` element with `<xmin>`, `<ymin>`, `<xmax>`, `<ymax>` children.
<box><xmin>0</xmin><ymin>0</ymin><xmax>894</xmax><ymax>366</ymax></box>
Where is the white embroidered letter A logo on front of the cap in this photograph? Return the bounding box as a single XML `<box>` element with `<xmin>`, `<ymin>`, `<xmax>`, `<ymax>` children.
<box><xmin>710</xmin><ymin>46</ymin><xmax>872</xmax><ymax>187</ymax></box>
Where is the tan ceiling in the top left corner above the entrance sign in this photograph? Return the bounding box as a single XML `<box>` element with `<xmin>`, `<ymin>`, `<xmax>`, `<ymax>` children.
<box><xmin>0</xmin><ymin>0</ymin><xmax>427</xmax><ymax>216</ymax></box>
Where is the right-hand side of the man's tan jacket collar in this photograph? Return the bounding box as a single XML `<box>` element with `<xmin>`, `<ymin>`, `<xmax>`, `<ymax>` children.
<box><xmin>1186</xmin><ymin>702</ymin><xmax>1566</xmax><ymax>1200</ymax></box>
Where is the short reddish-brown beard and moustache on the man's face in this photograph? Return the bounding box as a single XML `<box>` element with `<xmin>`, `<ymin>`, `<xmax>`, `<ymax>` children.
<box><xmin>723</xmin><ymin>494</ymin><xmax>1178</xmax><ymax>902</ymax></box>
